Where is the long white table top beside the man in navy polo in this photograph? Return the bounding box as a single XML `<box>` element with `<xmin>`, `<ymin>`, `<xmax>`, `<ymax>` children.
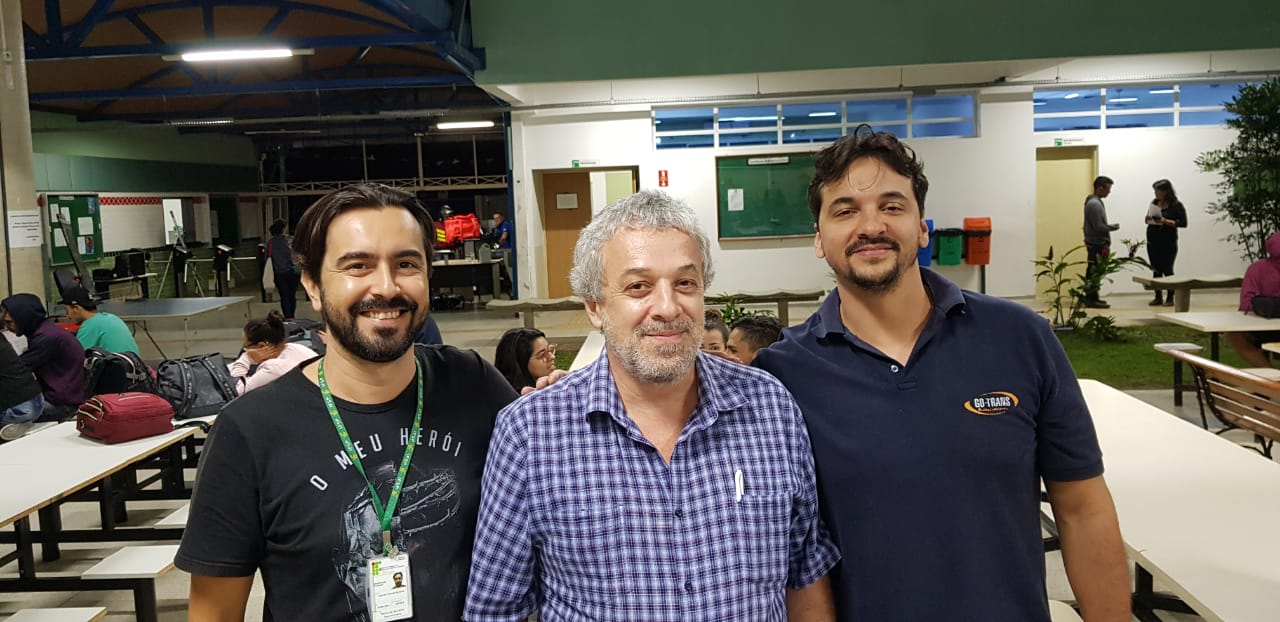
<box><xmin>1080</xmin><ymin>380</ymin><xmax>1280</xmax><ymax>622</ymax></box>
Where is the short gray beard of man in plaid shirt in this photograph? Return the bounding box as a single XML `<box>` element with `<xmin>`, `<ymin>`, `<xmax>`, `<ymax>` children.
<box><xmin>603</xmin><ymin>314</ymin><xmax>699</xmax><ymax>384</ymax></box>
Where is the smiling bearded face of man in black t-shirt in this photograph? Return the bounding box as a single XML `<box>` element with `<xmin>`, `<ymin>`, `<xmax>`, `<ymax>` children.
<box><xmin>302</xmin><ymin>207</ymin><xmax>428</xmax><ymax>362</ymax></box>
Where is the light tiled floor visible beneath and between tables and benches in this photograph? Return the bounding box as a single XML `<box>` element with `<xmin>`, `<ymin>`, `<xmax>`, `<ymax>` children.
<box><xmin>0</xmin><ymin>285</ymin><xmax>1259</xmax><ymax>622</ymax></box>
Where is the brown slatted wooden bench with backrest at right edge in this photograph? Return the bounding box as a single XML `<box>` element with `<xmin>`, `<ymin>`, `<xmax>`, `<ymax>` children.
<box><xmin>1171</xmin><ymin>352</ymin><xmax>1280</xmax><ymax>458</ymax></box>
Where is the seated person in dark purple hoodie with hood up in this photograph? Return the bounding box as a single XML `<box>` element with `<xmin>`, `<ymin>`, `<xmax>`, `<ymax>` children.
<box><xmin>0</xmin><ymin>293</ymin><xmax>84</xmax><ymax>421</ymax></box>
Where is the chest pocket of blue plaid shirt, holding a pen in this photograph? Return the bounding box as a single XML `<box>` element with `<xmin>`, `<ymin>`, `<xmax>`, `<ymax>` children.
<box><xmin>732</xmin><ymin>494</ymin><xmax>791</xmax><ymax>589</ymax></box>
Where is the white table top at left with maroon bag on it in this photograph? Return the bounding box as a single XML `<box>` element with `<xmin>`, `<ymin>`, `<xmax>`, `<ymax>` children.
<box><xmin>0</xmin><ymin>421</ymin><xmax>197</xmax><ymax>527</ymax></box>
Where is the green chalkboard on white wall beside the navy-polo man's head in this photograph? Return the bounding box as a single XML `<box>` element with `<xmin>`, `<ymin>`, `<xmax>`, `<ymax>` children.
<box><xmin>716</xmin><ymin>154</ymin><xmax>814</xmax><ymax>239</ymax></box>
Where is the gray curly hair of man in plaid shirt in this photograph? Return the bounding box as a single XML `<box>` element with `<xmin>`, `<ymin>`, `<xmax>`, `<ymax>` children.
<box><xmin>568</xmin><ymin>191</ymin><xmax>716</xmax><ymax>301</ymax></box>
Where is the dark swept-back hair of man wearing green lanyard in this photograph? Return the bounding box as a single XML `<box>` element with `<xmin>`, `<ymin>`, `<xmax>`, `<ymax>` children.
<box><xmin>293</xmin><ymin>183</ymin><xmax>435</xmax><ymax>283</ymax></box>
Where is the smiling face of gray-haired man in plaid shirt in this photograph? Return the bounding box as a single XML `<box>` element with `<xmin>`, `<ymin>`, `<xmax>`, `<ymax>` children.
<box><xmin>586</xmin><ymin>229</ymin><xmax>703</xmax><ymax>384</ymax></box>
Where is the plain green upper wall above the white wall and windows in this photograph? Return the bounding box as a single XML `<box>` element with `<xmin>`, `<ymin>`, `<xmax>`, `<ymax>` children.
<box><xmin>471</xmin><ymin>0</ymin><xmax>1280</xmax><ymax>84</ymax></box>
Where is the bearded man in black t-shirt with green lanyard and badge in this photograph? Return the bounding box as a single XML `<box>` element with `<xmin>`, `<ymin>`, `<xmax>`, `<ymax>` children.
<box><xmin>177</xmin><ymin>186</ymin><xmax>516</xmax><ymax>622</ymax></box>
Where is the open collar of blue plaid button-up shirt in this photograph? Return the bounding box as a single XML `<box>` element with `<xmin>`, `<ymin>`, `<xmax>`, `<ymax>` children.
<box><xmin>582</xmin><ymin>345</ymin><xmax>747</xmax><ymax>429</ymax></box>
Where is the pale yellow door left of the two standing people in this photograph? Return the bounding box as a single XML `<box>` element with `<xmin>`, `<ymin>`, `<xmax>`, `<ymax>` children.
<box><xmin>1036</xmin><ymin>146</ymin><xmax>1098</xmax><ymax>298</ymax></box>
